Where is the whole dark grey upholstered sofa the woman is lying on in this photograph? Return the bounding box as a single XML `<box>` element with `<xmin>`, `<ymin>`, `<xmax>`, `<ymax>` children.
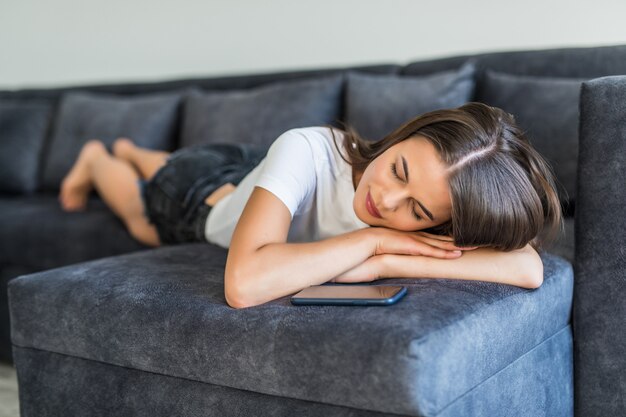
<box><xmin>0</xmin><ymin>46</ymin><xmax>626</xmax><ymax>416</ymax></box>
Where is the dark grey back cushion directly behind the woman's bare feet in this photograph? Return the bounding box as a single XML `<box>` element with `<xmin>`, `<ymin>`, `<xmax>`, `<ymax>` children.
<box><xmin>42</xmin><ymin>92</ymin><xmax>181</xmax><ymax>191</ymax></box>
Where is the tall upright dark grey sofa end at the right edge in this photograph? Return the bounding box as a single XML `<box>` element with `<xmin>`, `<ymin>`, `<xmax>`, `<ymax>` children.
<box><xmin>573</xmin><ymin>76</ymin><xmax>626</xmax><ymax>417</ymax></box>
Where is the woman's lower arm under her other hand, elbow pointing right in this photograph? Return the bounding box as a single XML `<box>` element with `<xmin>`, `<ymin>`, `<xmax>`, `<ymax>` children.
<box><xmin>332</xmin><ymin>245</ymin><xmax>543</xmax><ymax>288</ymax></box>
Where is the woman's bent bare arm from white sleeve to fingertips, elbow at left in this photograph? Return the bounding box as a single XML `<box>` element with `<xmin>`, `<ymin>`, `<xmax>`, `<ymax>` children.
<box><xmin>224</xmin><ymin>187</ymin><xmax>459</xmax><ymax>308</ymax></box>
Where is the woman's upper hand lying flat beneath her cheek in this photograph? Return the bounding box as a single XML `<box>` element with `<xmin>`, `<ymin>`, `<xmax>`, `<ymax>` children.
<box><xmin>370</xmin><ymin>228</ymin><xmax>476</xmax><ymax>259</ymax></box>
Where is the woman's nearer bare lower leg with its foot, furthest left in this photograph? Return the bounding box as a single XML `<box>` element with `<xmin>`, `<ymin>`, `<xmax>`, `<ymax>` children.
<box><xmin>59</xmin><ymin>140</ymin><xmax>160</xmax><ymax>246</ymax></box>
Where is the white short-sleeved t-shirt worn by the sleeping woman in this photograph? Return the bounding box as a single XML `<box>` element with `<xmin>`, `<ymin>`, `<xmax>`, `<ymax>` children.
<box><xmin>205</xmin><ymin>127</ymin><xmax>368</xmax><ymax>248</ymax></box>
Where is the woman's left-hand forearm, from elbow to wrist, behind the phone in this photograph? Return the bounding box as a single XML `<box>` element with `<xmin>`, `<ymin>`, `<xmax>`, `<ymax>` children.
<box><xmin>229</xmin><ymin>228</ymin><xmax>376</xmax><ymax>307</ymax></box>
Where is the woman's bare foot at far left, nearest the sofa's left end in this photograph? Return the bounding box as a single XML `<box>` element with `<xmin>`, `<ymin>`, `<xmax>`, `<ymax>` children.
<box><xmin>59</xmin><ymin>139</ymin><xmax>107</xmax><ymax>211</ymax></box>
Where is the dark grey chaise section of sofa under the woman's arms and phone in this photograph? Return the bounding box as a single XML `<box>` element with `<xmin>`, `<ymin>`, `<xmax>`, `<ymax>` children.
<box><xmin>9</xmin><ymin>243</ymin><xmax>573</xmax><ymax>417</ymax></box>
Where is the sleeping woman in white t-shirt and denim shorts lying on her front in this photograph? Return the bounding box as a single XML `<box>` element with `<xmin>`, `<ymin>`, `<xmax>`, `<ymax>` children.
<box><xmin>60</xmin><ymin>103</ymin><xmax>561</xmax><ymax>308</ymax></box>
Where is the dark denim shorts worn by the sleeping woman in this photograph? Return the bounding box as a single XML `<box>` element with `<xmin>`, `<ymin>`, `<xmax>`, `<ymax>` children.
<box><xmin>140</xmin><ymin>143</ymin><xmax>267</xmax><ymax>244</ymax></box>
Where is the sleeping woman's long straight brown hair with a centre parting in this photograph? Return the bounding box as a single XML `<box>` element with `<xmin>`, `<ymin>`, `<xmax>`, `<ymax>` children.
<box><xmin>331</xmin><ymin>102</ymin><xmax>563</xmax><ymax>251</ymax></box>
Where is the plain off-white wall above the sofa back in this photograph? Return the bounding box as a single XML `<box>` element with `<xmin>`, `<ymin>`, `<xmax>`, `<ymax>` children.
<box><xmin>0</xmin><ymin>0</ymin><xmax>626</xmax><ymax>89</ymax></box>
